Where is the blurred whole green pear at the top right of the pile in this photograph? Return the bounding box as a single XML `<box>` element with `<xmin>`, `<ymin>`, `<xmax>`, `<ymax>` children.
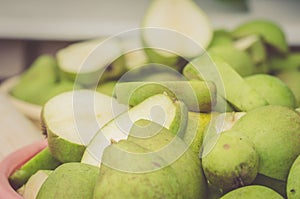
<box><xmin>232</xmin><ymin>19</ymin><xmax>288</xmax><ymax>54</ymax></box>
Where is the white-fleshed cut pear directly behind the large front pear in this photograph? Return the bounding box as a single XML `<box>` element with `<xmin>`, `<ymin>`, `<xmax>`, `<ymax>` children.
<box><xmin>81</xmin><ymin>94</ymin><xmax>188</xmax><ymax>166</ymax></box>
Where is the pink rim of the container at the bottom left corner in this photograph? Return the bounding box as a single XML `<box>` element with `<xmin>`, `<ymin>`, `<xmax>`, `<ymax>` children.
<box><xmin>0</xmin><ymin>140</ymin><xmax>47</xmax><ymax>199</ymax></box>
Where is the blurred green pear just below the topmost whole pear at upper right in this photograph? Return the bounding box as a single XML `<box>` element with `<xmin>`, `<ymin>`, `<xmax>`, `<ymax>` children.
<box><xmin>208</xmin><ymin>46</ymin><xmax>255</xmax><ymax>77</ymax></box>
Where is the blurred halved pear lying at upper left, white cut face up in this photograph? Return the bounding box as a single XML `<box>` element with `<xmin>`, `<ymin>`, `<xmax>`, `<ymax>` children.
<box><xmin>56</xmin><ymin>39</ymin><xmax>125</xmax><ymax>87</ymax></box>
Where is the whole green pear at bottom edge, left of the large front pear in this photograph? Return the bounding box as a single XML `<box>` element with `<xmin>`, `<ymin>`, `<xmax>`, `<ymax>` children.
<box><xmin>36</xmin><ymin>162</ymin><xmax>99</xmax><ymax>199</ymax></box>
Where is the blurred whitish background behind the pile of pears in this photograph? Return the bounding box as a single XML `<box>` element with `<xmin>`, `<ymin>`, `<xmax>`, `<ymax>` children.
<box><xmin>0</xmin><ymin>0</ymin><xmax>300</xmax><ymax>80</ymax></box>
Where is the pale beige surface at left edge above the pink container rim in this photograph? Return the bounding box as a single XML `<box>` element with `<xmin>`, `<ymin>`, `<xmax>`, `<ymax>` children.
<box><xmin>0</xmin><ymin>92</ymin><xmax>43</xmax><ymax>161</ymax></box>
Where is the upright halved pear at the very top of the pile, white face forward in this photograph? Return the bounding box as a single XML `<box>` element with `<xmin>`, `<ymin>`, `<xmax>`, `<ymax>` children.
<box><xmin>142</xmin><ymin>0</ymin><xmax>213</xmax><ymax>63</ymax></box>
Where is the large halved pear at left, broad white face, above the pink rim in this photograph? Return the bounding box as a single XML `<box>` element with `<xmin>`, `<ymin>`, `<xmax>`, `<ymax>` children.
<box><xmin>42</xmin><ymin>90</ymin><xmax>127</xmax><ymax>163</ymax></box>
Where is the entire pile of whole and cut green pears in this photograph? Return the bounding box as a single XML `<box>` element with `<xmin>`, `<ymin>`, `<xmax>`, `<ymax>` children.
<box><xmin>9</xmin><ymin>0</ymin><xmax>300</xmax><ymax>199</ymax></box>
